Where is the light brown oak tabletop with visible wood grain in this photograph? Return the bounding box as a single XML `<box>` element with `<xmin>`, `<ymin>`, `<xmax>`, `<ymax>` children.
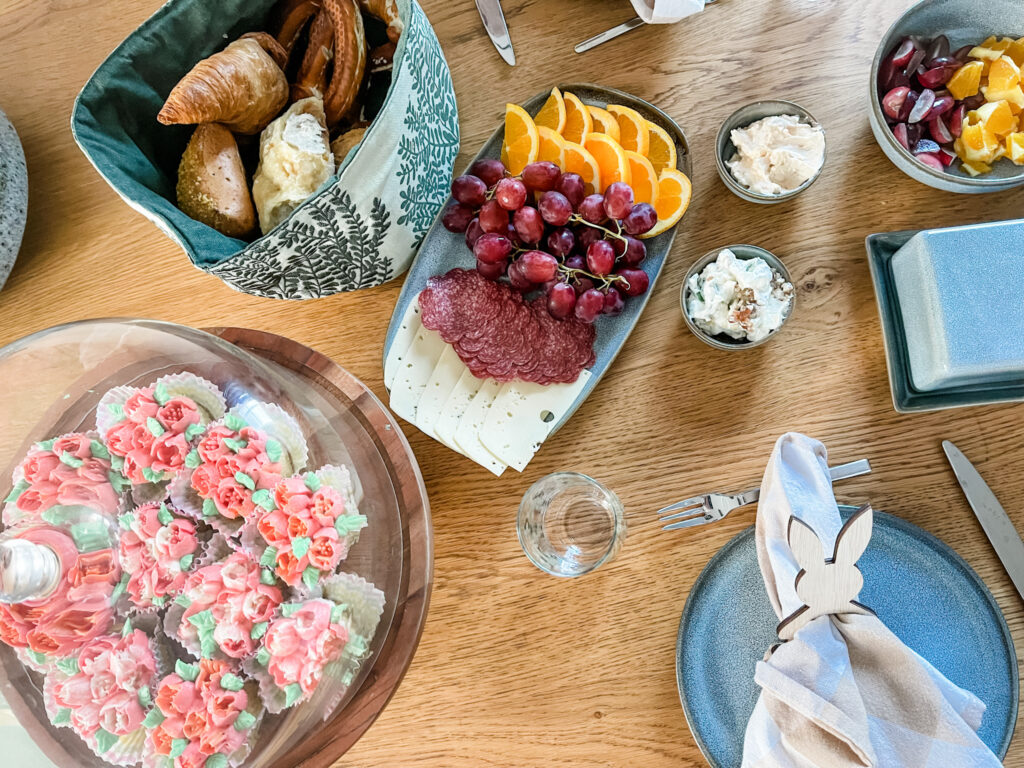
<box><xmin>0</xmin><ymin>0</ymin><xmax>1024</xmax><ymax>768</ymax></box>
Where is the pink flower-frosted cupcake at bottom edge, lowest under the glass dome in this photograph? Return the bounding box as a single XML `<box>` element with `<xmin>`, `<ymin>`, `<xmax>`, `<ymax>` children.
<box><xmin>145</xmin><ymin>658</ymin><xmax>262</xmax><ymax>768</ymax></box>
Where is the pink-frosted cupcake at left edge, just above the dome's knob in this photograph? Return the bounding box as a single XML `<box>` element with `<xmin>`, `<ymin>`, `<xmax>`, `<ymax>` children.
<box><xmin>3</xmin><ymin>432</ymin><xmax>127</xmax><ymax>525</ymax></box>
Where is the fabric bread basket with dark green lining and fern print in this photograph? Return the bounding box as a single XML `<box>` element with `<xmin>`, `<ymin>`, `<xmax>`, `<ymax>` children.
<box><xmin>72</xmin><ymin>0</ymin><xmax>459</xmax><ymax>299</ymax></box>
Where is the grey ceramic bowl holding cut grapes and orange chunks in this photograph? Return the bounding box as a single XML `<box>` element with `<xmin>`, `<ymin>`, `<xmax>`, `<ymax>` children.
<box><xmin>868</xmin><ymin>0</ymin><xmax>1024</xmax><ymax>195</ymax></box>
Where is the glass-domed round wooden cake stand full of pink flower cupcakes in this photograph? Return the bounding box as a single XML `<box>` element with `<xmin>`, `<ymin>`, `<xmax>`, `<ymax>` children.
<box><xmin>0</xmin><ymin>319</ymin><xmax>432</xmax><ymax>768</ymax></box>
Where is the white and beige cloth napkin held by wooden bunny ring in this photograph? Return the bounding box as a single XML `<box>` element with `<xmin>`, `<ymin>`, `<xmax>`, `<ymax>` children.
<box><xmin>742</xmin><ymin>433</ymin><xmax>999</xmax><ymax>768</ymax></box>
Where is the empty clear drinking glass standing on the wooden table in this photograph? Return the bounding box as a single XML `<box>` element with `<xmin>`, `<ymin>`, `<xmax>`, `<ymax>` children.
<box><xmin>516</xmin><ymin>472</ymin><xmax>626</xmax><ymax>577</ymax></box>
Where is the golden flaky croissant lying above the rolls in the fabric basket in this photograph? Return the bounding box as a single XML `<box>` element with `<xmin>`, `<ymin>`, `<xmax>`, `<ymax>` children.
<box><xmin>157</xmin><ymin>38</ymin><xmax>288</xmax><ymax>133</ymax></box>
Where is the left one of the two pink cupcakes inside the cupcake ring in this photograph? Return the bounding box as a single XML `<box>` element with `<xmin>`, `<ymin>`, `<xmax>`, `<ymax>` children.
<box><xmin>119</xmin><ymin>502</ymin><xmax>200</xmax><ymax>609</ymax></box>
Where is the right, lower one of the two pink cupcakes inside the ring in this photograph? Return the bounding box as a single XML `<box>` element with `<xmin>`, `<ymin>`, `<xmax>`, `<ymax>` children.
<box><xmin>164</xmin><ymin>552</ymin><xmax>284</xmax><ymax>660</ymax></box>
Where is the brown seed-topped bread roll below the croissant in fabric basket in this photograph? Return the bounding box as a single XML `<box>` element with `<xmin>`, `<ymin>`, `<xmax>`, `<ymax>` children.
<box><xmin>177</xmin><ymin>123</ymin><xmax>256</xmax><ymax>238</ymax></box>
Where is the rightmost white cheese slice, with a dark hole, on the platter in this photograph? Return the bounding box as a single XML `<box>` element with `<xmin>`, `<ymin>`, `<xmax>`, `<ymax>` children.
<box><xmin>479</xmin><ymin>371</ymin><xmax>590</xmax><ymax>472</ymax></box>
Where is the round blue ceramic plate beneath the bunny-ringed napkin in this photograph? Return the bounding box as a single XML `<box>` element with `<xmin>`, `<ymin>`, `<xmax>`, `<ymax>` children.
<box><xmin>676</xmin><ymin>506</ymin><xmax>1018</xmax><ymax>768</ymax></box>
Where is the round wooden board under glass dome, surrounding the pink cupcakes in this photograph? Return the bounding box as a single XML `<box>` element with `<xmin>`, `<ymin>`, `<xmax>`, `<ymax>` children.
<box><xmin>0</xmin><ymin>319</ymin><xmax>432</xmax><ymax>768</ymax></box>
